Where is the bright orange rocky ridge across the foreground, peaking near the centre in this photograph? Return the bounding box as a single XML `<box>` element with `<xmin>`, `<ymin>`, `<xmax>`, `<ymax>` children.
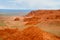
<box><xmin>0</xmin><ymin>26</ymin><xmax>60</xmax><ymax>40</ymax></box>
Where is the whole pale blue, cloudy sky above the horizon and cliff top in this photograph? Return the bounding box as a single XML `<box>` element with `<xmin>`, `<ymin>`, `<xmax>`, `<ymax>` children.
<box><xmin>0</xmin><ymin>0</ymin><xmax>60</xmax><ymax>10</ymax></box>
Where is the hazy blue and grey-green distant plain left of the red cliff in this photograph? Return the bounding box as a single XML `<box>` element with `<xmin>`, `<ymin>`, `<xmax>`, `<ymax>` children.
<box><xmin>0</xmin><ymin>9</ymin><xmax>31</xmax><ymax>16</ymax></box>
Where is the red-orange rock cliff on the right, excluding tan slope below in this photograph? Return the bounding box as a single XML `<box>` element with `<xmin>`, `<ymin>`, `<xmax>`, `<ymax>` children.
<box><xmin>24</xmin><ymin>10</ymin><xmax>60</xmax><ymax>25</ymax></box>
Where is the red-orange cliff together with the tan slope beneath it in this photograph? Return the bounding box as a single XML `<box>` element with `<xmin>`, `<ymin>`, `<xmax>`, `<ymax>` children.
<box><xmin>24</xmin><ymin>10</ymin><xmax>60</xmax><ymax>36</ymax></box>
